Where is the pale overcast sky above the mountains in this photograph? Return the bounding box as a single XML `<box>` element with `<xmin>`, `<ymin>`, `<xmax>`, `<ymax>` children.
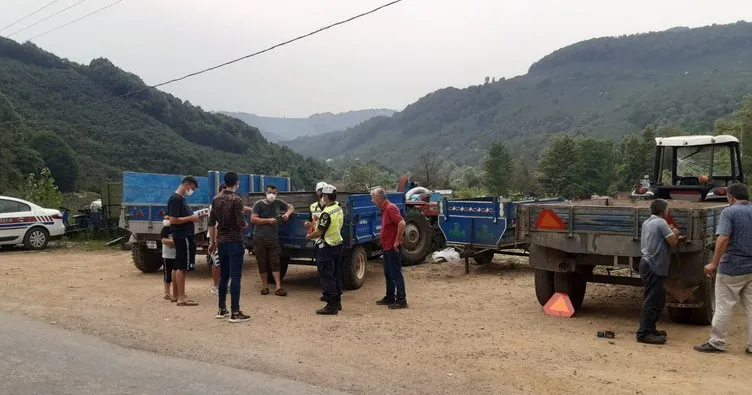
<box><xmin>0</xmin><ymin>0</ymin><xmax>752</xmax><ymax>117</ymax></box>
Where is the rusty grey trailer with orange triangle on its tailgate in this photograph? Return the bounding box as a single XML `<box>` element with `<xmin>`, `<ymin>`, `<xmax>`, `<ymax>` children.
<box><xmin>516</xmin><ymin>199</ymin><xmax>726</xmax><ymax>324</ymax></box>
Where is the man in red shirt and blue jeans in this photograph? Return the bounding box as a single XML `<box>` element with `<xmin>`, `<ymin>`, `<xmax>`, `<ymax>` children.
<box><xmin>371</xmin><ymin>188</ymin><xmax>407</xmax><ymax>309</ymax></box>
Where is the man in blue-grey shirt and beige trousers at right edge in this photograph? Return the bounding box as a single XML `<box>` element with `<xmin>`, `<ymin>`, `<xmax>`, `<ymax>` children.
<box><xmin>695</xmin><ymin>184</ymin><xmax>752</xmax><ymax>355</ymax></box>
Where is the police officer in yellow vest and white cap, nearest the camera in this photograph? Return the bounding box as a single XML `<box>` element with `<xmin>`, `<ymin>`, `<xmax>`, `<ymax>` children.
<box><xmin>308</xmin><ymin>185</ymin><xmax>345</xmax><ymax>315</ymax></box>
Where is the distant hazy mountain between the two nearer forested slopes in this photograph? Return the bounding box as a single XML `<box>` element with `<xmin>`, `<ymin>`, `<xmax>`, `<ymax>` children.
<box><xmin>221</xmin><ymin>109</ymin><xmax>396</xmax><ymax>142</ymax></box>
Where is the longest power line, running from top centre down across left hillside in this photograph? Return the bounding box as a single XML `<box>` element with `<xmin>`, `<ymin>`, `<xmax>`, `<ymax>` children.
<box><xmin>0</xmin><ymin>0</ymin><xmax>403</xmax><ymax>125</ymax></box>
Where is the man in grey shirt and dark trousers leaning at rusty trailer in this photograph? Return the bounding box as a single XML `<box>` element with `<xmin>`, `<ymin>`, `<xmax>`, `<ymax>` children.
<box><xmin>637</xmin><ymin>199</ymin><xmax>679</xmax><ymax>344</ymax></box>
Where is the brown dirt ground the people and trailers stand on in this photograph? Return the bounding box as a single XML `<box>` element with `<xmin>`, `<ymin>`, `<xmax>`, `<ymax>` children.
<box><xmin>0</xmin><ymin>249</ymin><xmax>752</xmax><ymax>394</ymax></box>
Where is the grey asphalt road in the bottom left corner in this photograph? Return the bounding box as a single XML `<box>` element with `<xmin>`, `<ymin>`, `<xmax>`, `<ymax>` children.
<box><xmin>0</xmin><ymin>312</ymin><xmax>340</xmax><ymax>394</ymax></box>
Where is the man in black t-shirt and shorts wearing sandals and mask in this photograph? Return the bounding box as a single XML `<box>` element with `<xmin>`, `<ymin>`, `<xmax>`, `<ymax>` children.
<box><xmin>167</xmin><ymin>176</ymin><xmax>204</xmax><ymax>306</ymax></box>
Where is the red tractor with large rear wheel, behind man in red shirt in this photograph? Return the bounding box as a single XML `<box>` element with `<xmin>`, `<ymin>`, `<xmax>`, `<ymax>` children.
<box><xmin>397</xmin><ymin>176</ymin><xmax>446</xmax><ymax>265</ymax></box>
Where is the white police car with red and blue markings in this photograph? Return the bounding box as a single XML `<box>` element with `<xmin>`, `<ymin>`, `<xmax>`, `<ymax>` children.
<box><xmin>0</xmin><ymin>196</ymin><xmax>65</xmax><ymax>250</ymax></box>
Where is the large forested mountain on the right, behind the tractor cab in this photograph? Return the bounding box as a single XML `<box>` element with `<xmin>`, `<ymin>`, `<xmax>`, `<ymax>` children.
<box><xmin>285</xmin><ymin>22</ymin><xmax>752</xmax><ymax>171</ymax></box>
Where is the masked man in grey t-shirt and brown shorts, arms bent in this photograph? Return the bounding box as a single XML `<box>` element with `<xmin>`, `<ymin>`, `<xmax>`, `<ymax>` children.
<box><xmin>251</xmin><ymin>185</ymin><xmax>295</xmax><ymax>296</ymax></box>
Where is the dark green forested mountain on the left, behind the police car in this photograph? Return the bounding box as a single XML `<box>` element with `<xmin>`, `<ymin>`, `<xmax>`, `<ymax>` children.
<box><xmin>0</xmin><ymin>37</ymin><xmax>330</xmax><ymax>194</ymax></box>
